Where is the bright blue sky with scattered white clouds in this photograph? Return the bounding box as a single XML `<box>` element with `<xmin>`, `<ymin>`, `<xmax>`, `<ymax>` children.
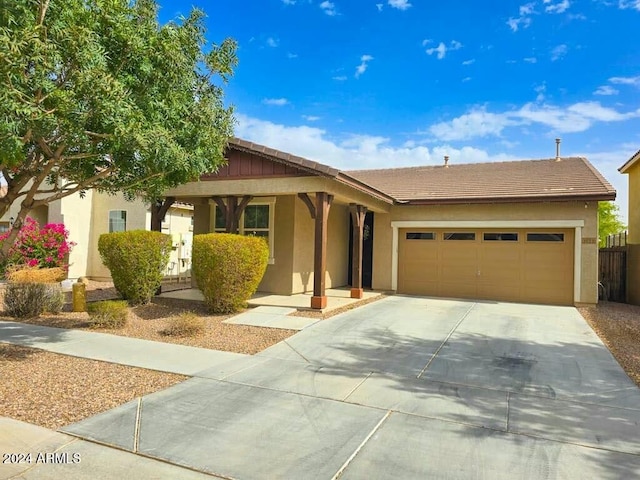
<box><xmin>159</xmin><ymin>0</ymin><xmax>640</xmax><ymax>218</ymax></box>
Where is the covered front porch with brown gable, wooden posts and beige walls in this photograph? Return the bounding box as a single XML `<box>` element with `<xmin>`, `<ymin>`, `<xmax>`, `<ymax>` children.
<box><xmin>167</xmin><ymin>139</ymin><xmax>393</xmax><ymax>312</ymax></box>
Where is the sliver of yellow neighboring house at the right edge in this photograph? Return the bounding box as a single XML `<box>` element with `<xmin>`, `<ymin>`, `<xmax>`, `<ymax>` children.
<box><xmin>618</xmin><ymin>150</ymin><xmax>640</xmax><ymax>305</ymax></box>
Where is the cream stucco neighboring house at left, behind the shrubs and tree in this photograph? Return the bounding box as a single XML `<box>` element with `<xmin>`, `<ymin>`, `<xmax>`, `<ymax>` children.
<box><xmin>0</xmin><ymin>190</ymin><xmax>193</xmax><ymax>280</ymax></box>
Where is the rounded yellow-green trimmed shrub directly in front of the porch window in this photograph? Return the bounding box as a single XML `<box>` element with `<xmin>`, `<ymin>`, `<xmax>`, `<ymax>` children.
<box><xmin>192</xmin><ymin>233</ymin><xmax>269</xmax><ymax>313</ymax></box>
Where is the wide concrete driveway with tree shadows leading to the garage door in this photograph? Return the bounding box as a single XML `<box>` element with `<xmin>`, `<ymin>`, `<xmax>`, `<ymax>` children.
<box><xmin>63</xmin><ymin>296</ymin><xmax>640</xmax><ymax>480</ymax></box>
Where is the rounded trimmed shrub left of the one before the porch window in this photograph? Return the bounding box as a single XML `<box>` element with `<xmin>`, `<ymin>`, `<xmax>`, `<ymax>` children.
<box><xmin>98</xmin><ymin>230</ymin><xmax>171</xmax><ymax>305</ymax></box>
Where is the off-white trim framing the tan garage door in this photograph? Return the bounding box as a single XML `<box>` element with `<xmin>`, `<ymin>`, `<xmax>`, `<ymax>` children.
<box><xmin>391</xmin><ymin>220</ymin><xmax>584</xmax><ymax>303</ymax></box>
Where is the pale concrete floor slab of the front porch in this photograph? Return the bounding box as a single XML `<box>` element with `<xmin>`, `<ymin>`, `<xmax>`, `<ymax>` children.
<box><xmin>158</xmin><ymin>288</ymin><xmax>382</xmax><ymax>314</ymax></box>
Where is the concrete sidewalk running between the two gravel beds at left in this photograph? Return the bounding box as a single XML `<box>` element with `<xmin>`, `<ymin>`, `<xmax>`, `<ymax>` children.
<box><xmin>0</xmin><ymin>321</ymin><xmax>249</xmax><ymax>376</ymax></box>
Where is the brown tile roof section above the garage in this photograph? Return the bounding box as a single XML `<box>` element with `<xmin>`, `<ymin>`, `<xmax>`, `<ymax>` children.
<box><xmin>345</xmin><ymin>157</ymin><xmax>615</xmax><ymax>203</ymax></box>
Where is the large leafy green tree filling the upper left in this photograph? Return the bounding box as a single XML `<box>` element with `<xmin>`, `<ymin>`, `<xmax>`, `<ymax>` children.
<box><xmin>0</xmin><ymin>0</ymin><xmax>237</xmax><ymax>254</ymax></box>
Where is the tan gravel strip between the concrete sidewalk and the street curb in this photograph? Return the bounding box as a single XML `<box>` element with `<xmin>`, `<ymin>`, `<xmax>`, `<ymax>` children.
<box><xmin>0</xmin><ymin>343</ymin><xmax>187</xmax><ymax>429</ymax></box>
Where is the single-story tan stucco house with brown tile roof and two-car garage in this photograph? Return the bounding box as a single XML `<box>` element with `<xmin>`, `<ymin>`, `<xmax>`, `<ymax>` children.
<box><xmin>167</xmin><ymin>139</ymin><xmax>615</xmax><ymax>308</ymax></box>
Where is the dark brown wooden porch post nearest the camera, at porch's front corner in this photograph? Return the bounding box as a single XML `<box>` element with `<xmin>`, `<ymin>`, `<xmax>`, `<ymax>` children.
<box><xmin>311</xmin><ymin>192</ymin><xmax>333</xmax><ymax>309</ymax></box>
